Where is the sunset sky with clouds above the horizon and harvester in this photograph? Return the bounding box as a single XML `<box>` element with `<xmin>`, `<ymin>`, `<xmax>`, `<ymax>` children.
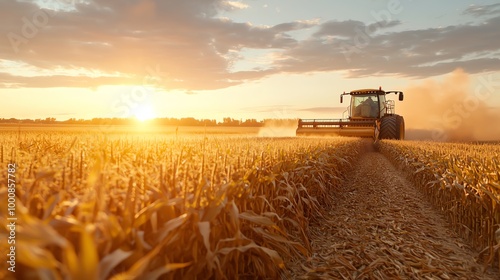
<box><xmin>0</xmin><ymin>0</ymin><xmax>500</xmax><ymax>124</ymax></box>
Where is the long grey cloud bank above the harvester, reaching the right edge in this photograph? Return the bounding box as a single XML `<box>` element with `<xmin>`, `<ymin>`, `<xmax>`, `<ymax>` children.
<box><xmin>277</xmin><ymin>17</ymin><xmax>500</xmax><ymax>77</ymax></box>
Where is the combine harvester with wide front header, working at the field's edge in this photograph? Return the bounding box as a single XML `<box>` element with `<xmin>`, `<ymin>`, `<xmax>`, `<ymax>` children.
<box><xmin>296</xmin><ymin>88</ymin><xmax>405</xmax><ymax>141</ymax></box>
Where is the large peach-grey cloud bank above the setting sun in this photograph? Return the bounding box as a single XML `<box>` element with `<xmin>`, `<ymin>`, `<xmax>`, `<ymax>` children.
<box><xmin>0</xmin><ymin>0</ymin><xmax>308</xmax><ymax>90</ymax></box>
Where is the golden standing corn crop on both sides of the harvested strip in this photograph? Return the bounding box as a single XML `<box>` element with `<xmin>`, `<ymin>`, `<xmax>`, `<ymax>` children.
<box><xmin>0</xmin><ymin>129</ymin><xmax>500</xmax><ymax>279</ymax></box>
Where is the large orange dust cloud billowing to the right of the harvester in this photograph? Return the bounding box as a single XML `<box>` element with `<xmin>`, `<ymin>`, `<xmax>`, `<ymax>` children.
<box><xmin>396</xmin><ymin>69</ymin><xmax>500</xmax><ymax>141</ymax></box>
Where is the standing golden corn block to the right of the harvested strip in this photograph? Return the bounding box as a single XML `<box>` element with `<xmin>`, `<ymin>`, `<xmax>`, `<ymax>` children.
<box><xmin>379</xmin><ymin>141</ymin><xmax>500</xmax><ymax>266</ymax></box>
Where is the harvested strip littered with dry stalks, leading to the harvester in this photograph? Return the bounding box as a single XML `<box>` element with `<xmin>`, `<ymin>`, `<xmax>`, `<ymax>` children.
<box><xmin>292</xmin><ymin>151</ymin><xmax>499</xmax><ymax>279</ymax></box>
